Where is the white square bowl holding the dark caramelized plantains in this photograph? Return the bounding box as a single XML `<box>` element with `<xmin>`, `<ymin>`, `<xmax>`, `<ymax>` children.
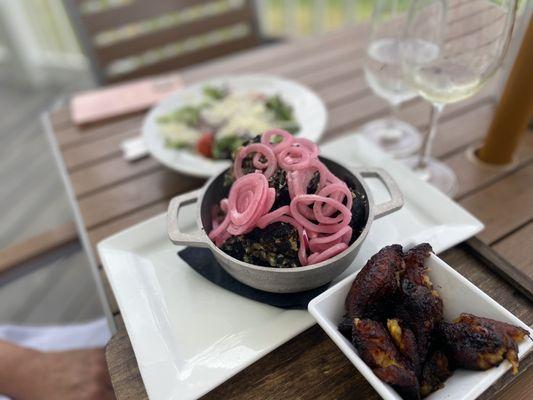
<box><xmin>309</xmin><ymin>255</ymin><xmax>533</xmax><ymax>400</ymax></box>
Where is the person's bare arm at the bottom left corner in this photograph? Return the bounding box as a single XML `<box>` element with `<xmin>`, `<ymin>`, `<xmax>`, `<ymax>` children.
<box><xmin>0</xmin><ymin>340</ymin><xmax>115</xmax><ymax>400</ymax></box>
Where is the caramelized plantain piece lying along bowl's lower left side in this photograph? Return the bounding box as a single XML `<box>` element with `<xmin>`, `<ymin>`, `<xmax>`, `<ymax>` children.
<box><xmin>353</xmin><ymin>318</ymin><xmax>420</xmax><ymax>399</ymax></box>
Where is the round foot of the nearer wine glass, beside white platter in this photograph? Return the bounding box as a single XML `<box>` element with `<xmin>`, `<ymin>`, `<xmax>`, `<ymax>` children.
<box><xmin>402</xmin><ymin>156</ymin><xmax>458</xmax><ymax>197</ymax></box>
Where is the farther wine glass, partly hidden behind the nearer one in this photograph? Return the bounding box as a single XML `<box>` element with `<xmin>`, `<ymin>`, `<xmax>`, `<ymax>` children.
<box><xmin>360</xmin><ymin>0</ymin><xmax>430</xmax><ymax>157</ymax></box>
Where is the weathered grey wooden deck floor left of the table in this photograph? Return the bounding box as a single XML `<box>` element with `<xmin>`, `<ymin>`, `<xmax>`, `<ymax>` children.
<box><xmin>0</xmin><ymin>68</ymin><xmax>103</xmax><ymax>324</ymax></box>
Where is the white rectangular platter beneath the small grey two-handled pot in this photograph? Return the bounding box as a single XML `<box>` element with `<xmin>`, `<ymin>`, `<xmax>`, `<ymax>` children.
<box><xmin>98</xmin><ymin>134</ymin><xmax>483</xmax><ymax>400</ymax></box>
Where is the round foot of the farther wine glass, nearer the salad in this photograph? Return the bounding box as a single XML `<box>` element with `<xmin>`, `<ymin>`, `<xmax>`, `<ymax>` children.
<box><xmin>359</xmin><ymin>118</ymin><xmax>422</xmax><ymax>158</ymax></box>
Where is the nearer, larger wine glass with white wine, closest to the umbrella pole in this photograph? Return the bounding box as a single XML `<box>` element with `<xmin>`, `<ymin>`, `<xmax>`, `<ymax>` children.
<box><xmin>401</xmin><ymin>0</ymin><xmax>517</xmax><ymax>196</ymax></box>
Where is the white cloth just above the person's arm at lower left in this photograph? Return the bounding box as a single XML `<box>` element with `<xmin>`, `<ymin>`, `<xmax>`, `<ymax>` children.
<box><xmin>0</xmin><ymin>318</ymin><xmax>111</xmax><ymax>400</ymax></box>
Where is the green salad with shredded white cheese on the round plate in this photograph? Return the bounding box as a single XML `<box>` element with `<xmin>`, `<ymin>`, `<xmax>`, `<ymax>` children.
<box><xmin>157</xmin><ymin>86</ymin><xmax>300</xmax><ymax>159</ymax></box>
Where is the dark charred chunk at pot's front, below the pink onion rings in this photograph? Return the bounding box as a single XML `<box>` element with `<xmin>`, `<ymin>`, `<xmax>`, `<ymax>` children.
<box><xmin>220</xmin><ymin>222</ymin><xmax>301</xmax><ymax>268</ymax></box>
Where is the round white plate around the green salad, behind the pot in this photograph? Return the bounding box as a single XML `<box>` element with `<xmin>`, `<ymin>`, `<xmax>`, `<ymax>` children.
<box><xmin>142</xmin><ymin>74</ymin><xmax>327</xmax><ymax>178</ymax></box>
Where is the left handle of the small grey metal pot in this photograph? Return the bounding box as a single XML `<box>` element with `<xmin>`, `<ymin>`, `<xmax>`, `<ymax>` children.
<box><xmin>167</xmin><ymin>189</ymin><xmax>208</xmax><ymax>247</ymax></box>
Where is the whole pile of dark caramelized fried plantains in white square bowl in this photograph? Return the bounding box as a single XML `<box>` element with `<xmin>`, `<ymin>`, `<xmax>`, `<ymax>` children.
<box><xmin>339</xmin><ymin>243</ymin><xmax>529</xmax><ymax>399</ymax></box>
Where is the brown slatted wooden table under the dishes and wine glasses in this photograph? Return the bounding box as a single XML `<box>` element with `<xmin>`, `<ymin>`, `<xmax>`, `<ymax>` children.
<box><xmin>45</xmin><ymin>2</ymin><xmax>533</xmax><ymax>400</ymax></box>
